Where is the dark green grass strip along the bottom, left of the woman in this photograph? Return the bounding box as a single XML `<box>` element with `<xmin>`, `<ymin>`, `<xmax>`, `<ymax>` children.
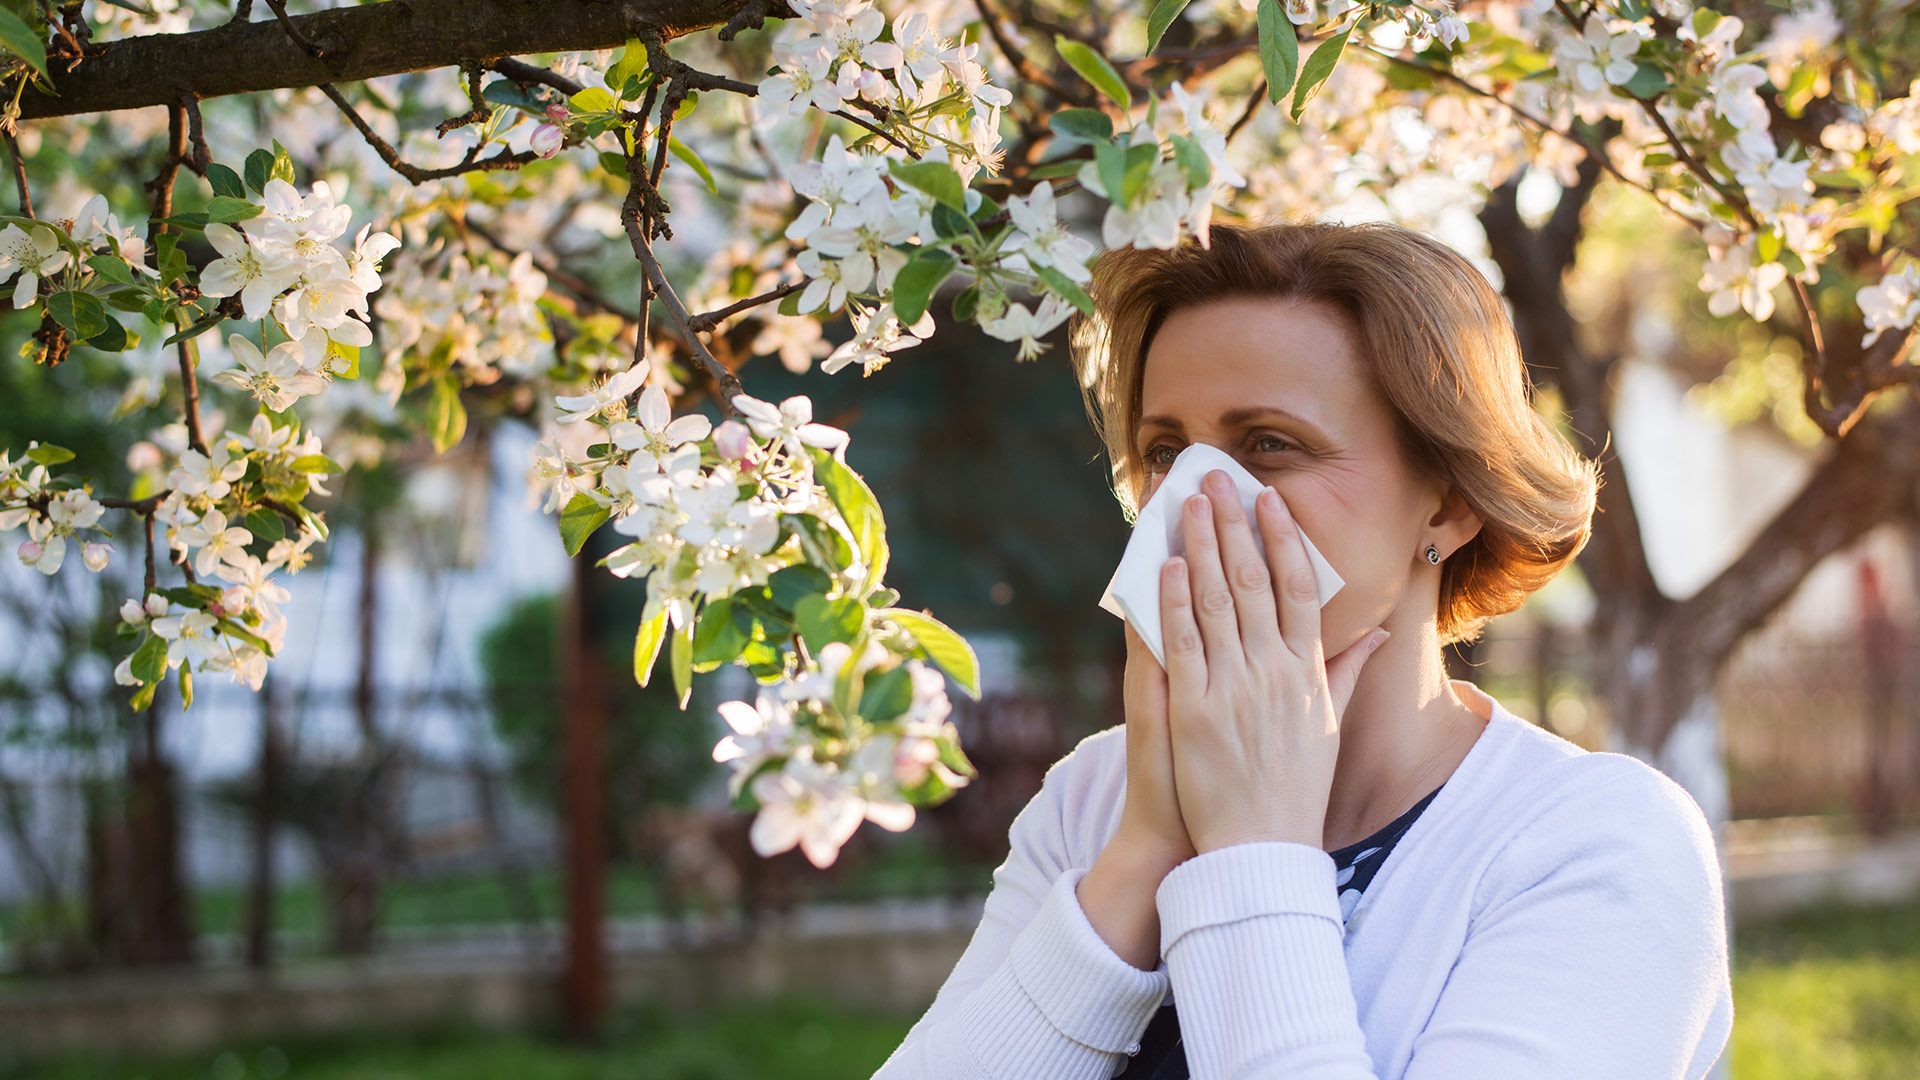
<box><xmin>0</xmin><ymin>997</ymin><xmax>912</xmax><ymax>1080</ymax></box>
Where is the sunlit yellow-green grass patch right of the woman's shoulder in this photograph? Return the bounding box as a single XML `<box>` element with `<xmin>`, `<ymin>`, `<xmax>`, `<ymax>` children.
<box><xmin>1732</xmin><ymin>887</ymin><xmax>1920</xmax><ymax>1080</ymax></box>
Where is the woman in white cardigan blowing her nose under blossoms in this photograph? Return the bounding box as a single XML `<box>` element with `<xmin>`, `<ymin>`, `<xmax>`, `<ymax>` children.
<box><xmin>876</xmin><ymin>225</ymin><xmax>1734</xmax><ymax>1080</ymax></box>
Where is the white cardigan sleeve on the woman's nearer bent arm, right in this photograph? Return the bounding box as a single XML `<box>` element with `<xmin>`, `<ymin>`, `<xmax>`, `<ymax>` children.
<box><xmin>1156</xmin><ymin>763</ymin><xmax>1734</xmax><ymax>1080</ymax></box>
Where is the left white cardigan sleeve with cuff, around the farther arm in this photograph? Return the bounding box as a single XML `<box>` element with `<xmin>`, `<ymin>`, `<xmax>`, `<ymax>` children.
<box><xmin>874</xmin><ymin>736</ymin><xmax>1169</xmax><ymax>1080</ymax></box>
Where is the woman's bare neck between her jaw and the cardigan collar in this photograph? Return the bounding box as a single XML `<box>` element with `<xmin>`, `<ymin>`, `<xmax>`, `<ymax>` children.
<box><xmin>1321</xmin><ymin>621</ymin><xmax>1492</xmax><ymax>851</ymax></box>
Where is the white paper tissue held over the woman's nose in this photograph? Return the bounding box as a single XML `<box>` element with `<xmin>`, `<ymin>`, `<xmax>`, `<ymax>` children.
<box><xmin>1100</xmin><ymin>442</ymin><xmax>1346</xmax><ymax>667</ymax></box>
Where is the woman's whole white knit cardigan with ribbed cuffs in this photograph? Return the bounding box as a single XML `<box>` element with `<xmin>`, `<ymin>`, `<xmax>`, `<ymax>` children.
<box><xmin>874</xmin><ymin>680</ymin><xmax>1734</xmax><ymax>1080</ymax></box>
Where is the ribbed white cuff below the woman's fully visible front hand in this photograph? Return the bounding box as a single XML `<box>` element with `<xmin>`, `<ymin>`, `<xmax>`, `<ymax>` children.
<box><xmin>1154</xmin><ymin>840</ymin><xmax>1342</xmax><ymax>959</ymax></box>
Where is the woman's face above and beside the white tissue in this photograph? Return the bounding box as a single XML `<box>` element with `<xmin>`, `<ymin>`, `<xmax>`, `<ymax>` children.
<box><xmin>1133</xmin><ymin>290</ymin><xmax>1478</xmax><ymax>657</ymax></box>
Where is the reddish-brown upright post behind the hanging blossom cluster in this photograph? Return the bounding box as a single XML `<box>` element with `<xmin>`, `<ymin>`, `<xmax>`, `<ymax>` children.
<box><xmin>557</xmin><ymin>544</ymin><xmax>607</xmax><ymax>1042</ymax></box>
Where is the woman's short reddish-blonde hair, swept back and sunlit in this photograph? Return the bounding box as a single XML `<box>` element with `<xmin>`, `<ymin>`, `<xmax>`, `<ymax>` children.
<box><xmin>1071</xmin><ymin>223</ymin><xmax>1599</xmax><ymax>644</ymax></box>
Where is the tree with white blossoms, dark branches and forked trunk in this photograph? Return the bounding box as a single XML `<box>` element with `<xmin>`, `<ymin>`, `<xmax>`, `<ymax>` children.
<box><xmin>0</xmin><ymin>0</ymin><xmax>1920</xmax><ymax>895</ymax></box>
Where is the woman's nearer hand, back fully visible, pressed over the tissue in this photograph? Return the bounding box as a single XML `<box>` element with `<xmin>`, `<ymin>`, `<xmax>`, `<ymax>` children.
<box><xmin>1129</xmin><ymin>469</ymin><xmax>1386</xmax><ymax>851</ymax></box>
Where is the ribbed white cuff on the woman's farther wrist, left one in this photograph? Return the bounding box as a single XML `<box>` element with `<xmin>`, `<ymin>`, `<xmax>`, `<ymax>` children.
<box><xmin>1010</xmin><ymin>867</ymin><xmax>1169</xmax><ymax>1053</ymax></box>
